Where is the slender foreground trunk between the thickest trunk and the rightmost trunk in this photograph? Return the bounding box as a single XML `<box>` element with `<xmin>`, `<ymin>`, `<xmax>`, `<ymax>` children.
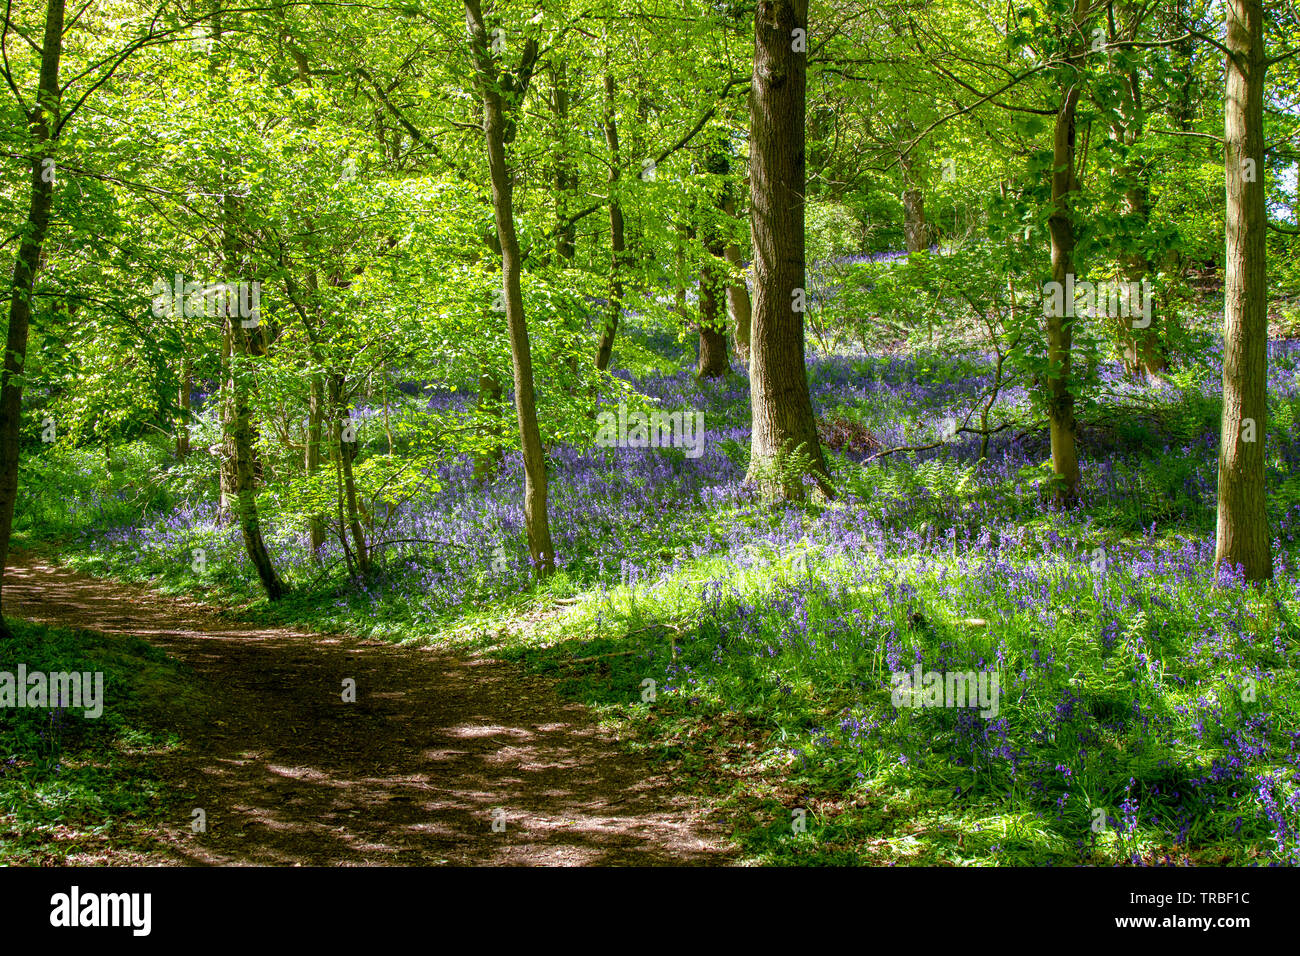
<box><xmin>1044</xmin><ymin>65</ymin><xmax>1079</xmax><ymax>503</ymax></box>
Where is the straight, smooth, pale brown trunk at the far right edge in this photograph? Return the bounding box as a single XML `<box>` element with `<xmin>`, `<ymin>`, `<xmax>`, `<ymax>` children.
<box><xmin>1214</xmin><ymin>0</ymin><xmax>1273</xmax><ymax>581</ymax></box>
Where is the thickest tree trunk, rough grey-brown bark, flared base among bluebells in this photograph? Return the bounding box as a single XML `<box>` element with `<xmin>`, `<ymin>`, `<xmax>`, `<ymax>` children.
<box><xmin>749</xmin><ymin>0</ymin><xmax>832</xmax><ymax>498</ymax></box>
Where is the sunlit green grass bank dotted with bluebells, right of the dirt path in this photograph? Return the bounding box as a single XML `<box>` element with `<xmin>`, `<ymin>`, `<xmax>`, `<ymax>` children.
<box><xmin>17</xmin><ymin>335</ymin><xmax>1300</xmax><ymax>865</ymax></box>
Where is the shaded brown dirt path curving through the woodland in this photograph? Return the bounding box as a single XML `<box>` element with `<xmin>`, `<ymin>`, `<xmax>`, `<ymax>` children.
<box><xmin>5</xmin><ymin>554</ymin><xmax>733</xmax><ymax>866</ymax></box>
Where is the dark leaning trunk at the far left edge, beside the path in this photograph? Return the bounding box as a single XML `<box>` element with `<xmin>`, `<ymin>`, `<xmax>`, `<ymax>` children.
<box><xmin>0</xmin><ymin>0</ymin><xmax>64</xmax><ymax>637</ymax></box>
